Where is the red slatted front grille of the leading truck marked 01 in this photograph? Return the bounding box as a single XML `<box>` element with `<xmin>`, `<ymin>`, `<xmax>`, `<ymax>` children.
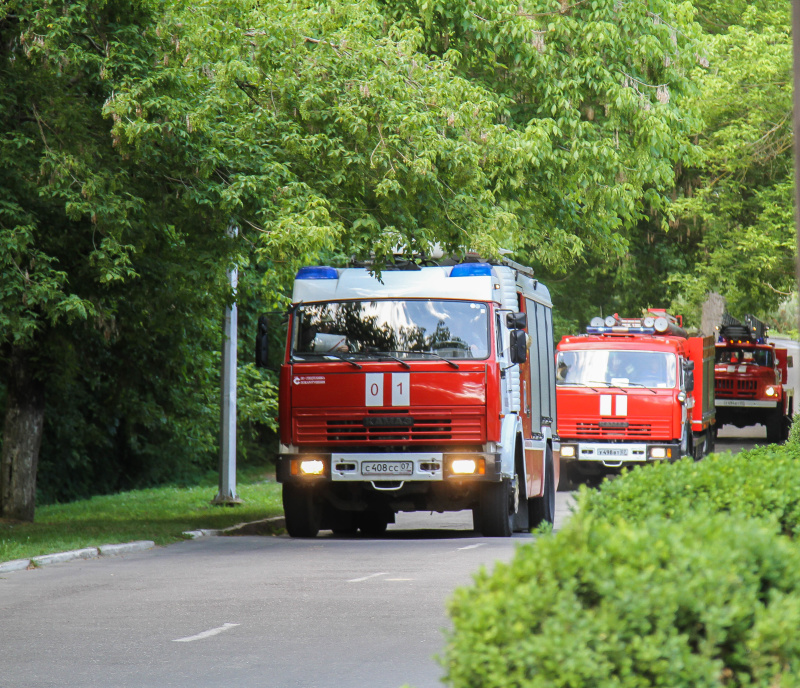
<box><xmin>294</xmin><ymin>408</ymin><xmax>486</xmax><ymax>445</ymax></box>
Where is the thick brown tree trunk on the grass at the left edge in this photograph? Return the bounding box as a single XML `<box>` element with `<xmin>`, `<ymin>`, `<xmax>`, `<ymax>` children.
<box><xmin>0</xmin><ymin>348</ymin><xmax>44</xmax><ymax>521</ymax></box>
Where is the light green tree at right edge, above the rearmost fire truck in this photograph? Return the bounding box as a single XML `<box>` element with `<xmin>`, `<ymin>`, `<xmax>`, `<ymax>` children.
<box><xmin>671</xmin><ymin>2</ymin><xmax>796</xmax><ymax>314</ymax></box>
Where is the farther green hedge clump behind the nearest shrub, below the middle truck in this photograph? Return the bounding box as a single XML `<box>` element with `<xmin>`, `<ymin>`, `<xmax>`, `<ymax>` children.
<box><xmin>579</xmin><ymin>443</ymin><xmax>800</xmax><ymax>536</ymax></box>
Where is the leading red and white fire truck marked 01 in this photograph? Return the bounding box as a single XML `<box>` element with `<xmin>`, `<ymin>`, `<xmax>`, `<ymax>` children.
<box><xmin>256</xmin><ymin>261</ymin><xmax>559</xmax><ymax>537</ymax></box>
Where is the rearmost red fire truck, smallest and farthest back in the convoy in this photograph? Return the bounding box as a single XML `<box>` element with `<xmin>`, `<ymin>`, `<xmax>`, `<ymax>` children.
<box><xmin>714</xmin><ymin>313</ymin><xmax>794</xmax><ymax>442</ymax></box>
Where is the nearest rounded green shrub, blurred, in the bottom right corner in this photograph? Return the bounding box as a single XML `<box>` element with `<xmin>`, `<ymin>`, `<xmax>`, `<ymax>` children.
<box><xmin>443</xmin><ymin>514</ymin><xmax>800</xmax><ymax>688</ymax></box>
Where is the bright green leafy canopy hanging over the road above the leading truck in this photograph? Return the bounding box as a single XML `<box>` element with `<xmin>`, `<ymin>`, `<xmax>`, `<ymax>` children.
<box><xmin>106</xmin><ymin>0</ymin><xmax>708</xmax><ymax>288</ymax></box>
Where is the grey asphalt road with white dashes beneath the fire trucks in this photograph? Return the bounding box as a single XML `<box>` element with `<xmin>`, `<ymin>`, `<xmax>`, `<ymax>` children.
<box><xmin>0</xmin><ymin>426</ymin><xmax>766</xmax><ymax>688</ymax></box>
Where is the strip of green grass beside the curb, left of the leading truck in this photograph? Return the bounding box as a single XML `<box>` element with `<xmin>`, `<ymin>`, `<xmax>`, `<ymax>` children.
<box><xmin>0</xmin><ymin>470</ymin><xmax>283</xmax><ymax>562</ymax></box>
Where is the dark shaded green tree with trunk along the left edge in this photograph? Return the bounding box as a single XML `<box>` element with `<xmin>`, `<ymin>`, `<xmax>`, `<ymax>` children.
<box><xmin>0</xmin><ymin>0</ymin><xmax>234</xmax><ymax>520</ymax></box>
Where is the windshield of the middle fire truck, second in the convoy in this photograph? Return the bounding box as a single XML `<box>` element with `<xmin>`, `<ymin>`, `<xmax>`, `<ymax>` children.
<box><xmin>556</xmin><ymin>349</ymin><xmax>676</xmax><ymax>388</ymax></box>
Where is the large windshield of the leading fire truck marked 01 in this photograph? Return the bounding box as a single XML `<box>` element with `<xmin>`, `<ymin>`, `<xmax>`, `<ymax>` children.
<box><xmin>292</xmin><ymin>299</ymin><xmax>489</xmax><ymax>359</ymax></box>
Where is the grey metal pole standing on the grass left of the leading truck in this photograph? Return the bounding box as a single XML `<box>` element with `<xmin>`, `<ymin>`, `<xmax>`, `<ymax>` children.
<box><xmin>213</xmin><ymin>225</ymin><xmax>242</xmax><ymax>504</ymax></box>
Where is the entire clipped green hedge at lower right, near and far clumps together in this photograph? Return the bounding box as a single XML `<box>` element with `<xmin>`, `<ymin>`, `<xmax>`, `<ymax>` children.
<box><xmin>443</xmin><ymin>423</ymin><xmax>800</xmax><ymax>688</ymax></box>
